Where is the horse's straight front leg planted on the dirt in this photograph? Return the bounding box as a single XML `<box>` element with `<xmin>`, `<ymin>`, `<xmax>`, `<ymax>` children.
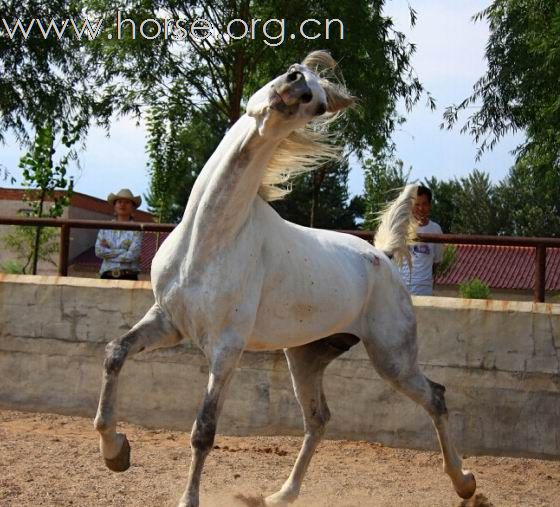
<box><xmin>179</xmin><ymin>333</ymin><xmax>244</xmax><ymax>507</ymax></box>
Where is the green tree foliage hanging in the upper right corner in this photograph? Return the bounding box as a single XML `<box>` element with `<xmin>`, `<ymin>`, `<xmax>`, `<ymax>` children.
<box><xmin>445</xmin><ymin>0</ymin><xmax>560</xmax><ymax>163</ymax></box>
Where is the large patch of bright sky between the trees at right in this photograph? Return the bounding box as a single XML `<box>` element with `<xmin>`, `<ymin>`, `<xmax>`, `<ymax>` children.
<box><xmin>382</xmin><ymin>0</ymin><xmax>522</xmax><ymax>189</ymax></box>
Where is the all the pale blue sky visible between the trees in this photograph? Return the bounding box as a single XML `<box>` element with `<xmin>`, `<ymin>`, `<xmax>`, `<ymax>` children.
<box><xmin>0</xmin><ymin>0</ymin><xmax>521</xmax><ymax>209</ymax></box>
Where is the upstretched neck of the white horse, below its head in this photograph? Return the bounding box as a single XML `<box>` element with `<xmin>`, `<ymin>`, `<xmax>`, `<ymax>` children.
<box><xmin>182</xmin><ymin>116</ymin><xmax>280</xmax><ymax>255</ymax></box>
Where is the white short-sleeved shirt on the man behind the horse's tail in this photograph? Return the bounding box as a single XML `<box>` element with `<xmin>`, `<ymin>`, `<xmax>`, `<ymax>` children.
<box><xmin>400</xmin><ymin>220</ymin><xmax>443</xmax><ymax>296</ymax></box>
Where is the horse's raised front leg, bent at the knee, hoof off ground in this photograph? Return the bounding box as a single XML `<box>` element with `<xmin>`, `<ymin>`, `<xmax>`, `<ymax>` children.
<box><xmin>94</xmin><ymin>305</ymin><xmax>182</xmax><ymax>472</ymax></box>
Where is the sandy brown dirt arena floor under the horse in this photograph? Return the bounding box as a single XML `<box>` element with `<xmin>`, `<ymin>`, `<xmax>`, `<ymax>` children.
<box><xmin>0</xmin><ymin>411</ymin><xmax>560</xmax><ymax>507</ymax></box>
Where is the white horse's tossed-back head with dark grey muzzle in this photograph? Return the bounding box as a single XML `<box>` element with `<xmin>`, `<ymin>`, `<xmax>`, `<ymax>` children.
<box><xmin>247</xmin><ymin>51</ymin><xmax>354</xmax><ymax>135</ymax></box>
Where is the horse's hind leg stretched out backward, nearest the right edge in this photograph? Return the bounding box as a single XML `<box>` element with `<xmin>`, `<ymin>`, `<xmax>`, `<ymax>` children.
<box><xmin>363</xmin><ymin>326</ymin><xmax>476</xmax><ymax>498</ymax></box>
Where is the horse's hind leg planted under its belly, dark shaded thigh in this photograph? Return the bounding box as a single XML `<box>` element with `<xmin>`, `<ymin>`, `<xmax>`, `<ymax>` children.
<box><xmin>265</xmin><ymin>335</ymin><xmax>359</xmax><ymax>506</ymax></box>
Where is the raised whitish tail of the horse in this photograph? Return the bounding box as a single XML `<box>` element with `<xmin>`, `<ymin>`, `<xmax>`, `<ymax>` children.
<box><xmin>374</xmin><ymin>185</ymin><xmax>418</xmax><ymax>264</ymax></box>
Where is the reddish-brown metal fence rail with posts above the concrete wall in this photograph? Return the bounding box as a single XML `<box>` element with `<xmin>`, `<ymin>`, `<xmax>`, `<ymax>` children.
<box><xmin>0</xmin><ymin>217</ymin><xmax>560</xmax><ymax>302</ymax></box>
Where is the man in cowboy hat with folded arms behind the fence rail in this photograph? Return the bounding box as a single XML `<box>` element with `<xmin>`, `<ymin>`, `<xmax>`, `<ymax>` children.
<box><xmin>95</xmin><ymin>188</ymin><xmax>142</xmax><ymax>280</ymax></box>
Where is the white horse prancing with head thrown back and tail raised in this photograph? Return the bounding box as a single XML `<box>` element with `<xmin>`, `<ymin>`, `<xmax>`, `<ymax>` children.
<box><xmin>95</xmin><ymin>52</ymin><xmax>476</xmax><ymax>507</ymax></box>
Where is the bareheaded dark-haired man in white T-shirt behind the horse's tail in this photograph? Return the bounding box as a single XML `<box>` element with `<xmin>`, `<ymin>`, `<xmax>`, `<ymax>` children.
<box><xmin>400</xmin><ymin>186</ymin><xmax>443</xmax><ymax>296</ymax></box>
